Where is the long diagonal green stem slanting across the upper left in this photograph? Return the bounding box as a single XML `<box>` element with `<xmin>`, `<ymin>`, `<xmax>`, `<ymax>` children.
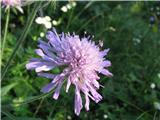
<box><xmin>1</xmin><ymin>1</ymin><xmax>42</xmax><ymax>80</ymax></box>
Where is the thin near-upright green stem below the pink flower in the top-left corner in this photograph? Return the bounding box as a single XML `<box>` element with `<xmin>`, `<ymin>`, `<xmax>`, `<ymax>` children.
<box><xmin>1</xmin><ymin>8</ymin><xmax>10</xmax><ymax>57</ymax></box>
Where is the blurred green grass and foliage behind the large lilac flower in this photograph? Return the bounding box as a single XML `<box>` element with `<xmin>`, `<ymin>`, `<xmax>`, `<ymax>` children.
<box><xmin>1</xmin><ymin>1</ymin><xmax>160</xmax><ymax>120</ymax></box>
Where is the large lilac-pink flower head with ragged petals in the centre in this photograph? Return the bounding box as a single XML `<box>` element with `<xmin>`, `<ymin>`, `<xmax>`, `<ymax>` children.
<box><xmin>26</xmin><ymin>29</ymin><xmax>112</xmax><ymax>115</ymax></box>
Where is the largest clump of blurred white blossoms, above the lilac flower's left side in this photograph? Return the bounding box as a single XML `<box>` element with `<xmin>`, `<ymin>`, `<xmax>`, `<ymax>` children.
<box><xmin>35</xmin><ymin>16</ymin><xmax>52</xmax><ymax>29</ymax></box>
